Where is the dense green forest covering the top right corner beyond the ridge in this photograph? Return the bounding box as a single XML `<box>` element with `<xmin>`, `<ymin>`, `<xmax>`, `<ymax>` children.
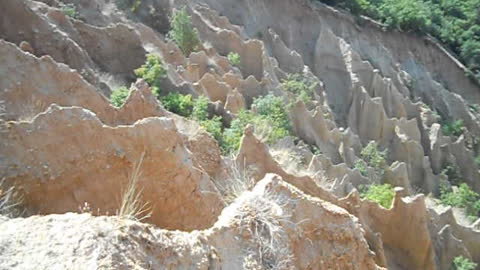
<box><xmin>319</xmin><ymin>0</ymin><xmax>480</xmax><ymax>83</ymax></box>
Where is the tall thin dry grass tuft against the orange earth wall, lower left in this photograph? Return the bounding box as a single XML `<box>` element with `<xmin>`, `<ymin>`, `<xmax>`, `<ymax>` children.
<box><xmin>117</xmin><ymin>152</ymin><xmax>152</xmax><ymax>221</ymax></box>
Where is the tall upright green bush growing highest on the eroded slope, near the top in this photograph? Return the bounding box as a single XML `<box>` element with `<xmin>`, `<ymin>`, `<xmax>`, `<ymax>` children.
<box><xmin>169</xmin><ymin>7</ymin><xmax>200</xmax><ymax>56</ymax></box>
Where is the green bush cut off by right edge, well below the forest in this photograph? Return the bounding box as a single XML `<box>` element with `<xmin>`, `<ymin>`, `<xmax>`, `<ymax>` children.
<box><xmin>440</xmin><ymin>183</ymin><xmax>480</xmax><ymax>220</ymax></box>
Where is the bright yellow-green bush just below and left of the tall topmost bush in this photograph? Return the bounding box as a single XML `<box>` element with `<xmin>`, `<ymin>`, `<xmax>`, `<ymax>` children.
<box><xmin>135</xmin><ymin>54</ymin><xmax>167</xmax><ymax>98</ymax></box>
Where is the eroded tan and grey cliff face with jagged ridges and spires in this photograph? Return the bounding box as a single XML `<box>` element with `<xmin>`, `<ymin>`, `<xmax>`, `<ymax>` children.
<box><xmin>0</xmin><ymin>0</ymin><xmax>480</xmax><ymax>270</ymax></box>
